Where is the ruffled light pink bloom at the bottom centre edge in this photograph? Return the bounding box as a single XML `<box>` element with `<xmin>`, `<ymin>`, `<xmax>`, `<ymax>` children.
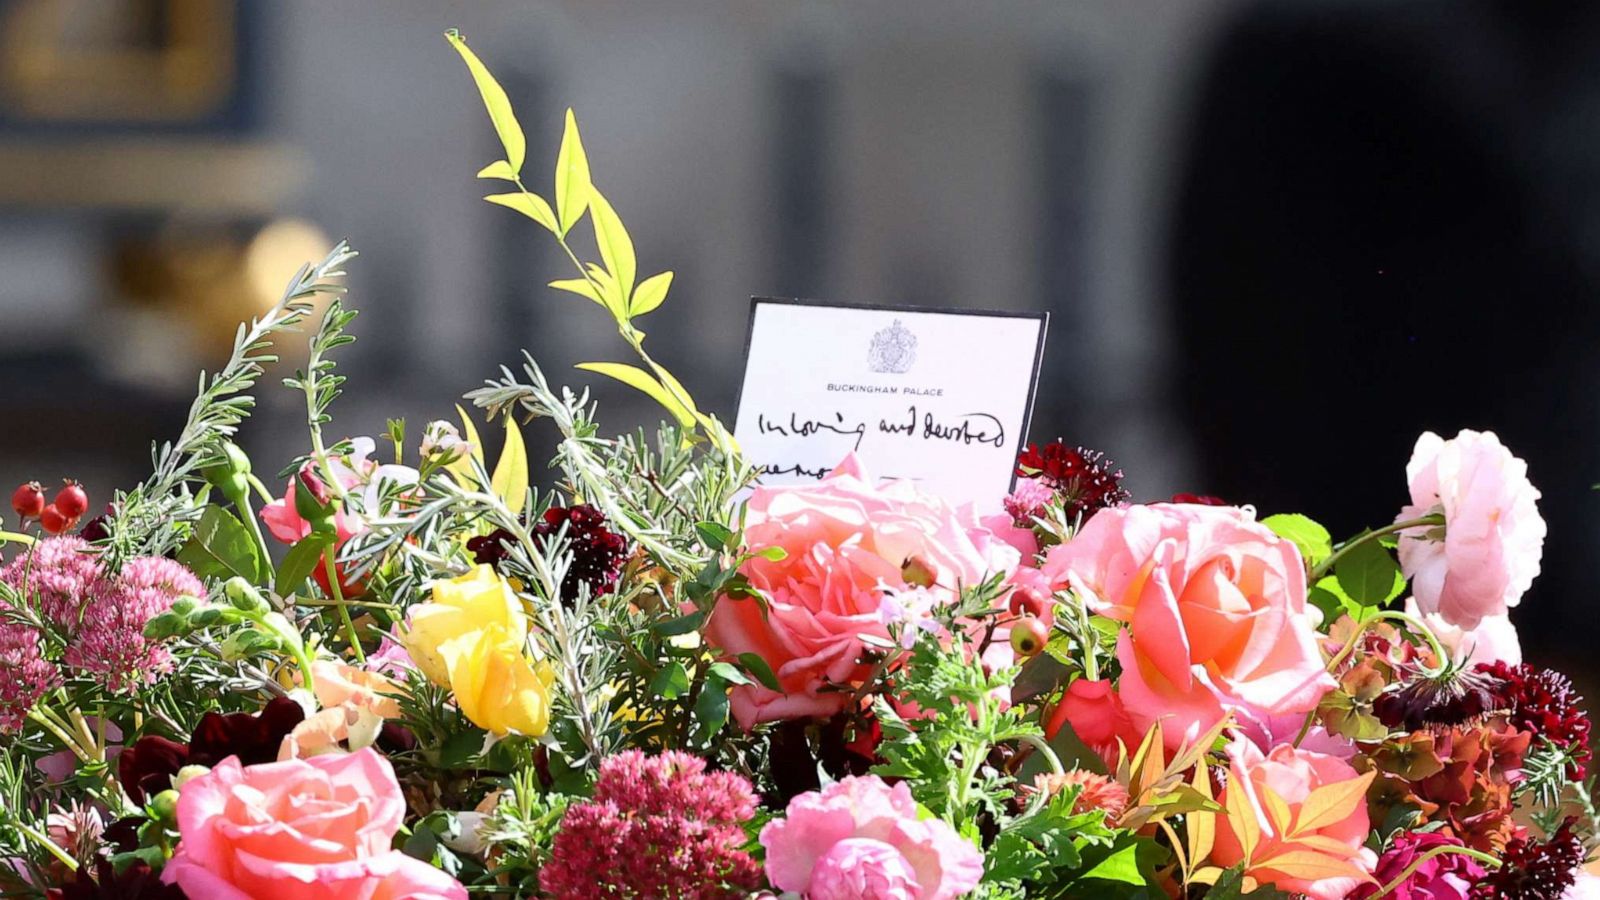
<box><xmin>762</xmin><ymin>775</ymin><xmax>984</xmax><ymax>900</ymax></box>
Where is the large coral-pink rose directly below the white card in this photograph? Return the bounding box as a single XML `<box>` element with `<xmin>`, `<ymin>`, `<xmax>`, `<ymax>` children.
<box><xmin>706</xmin><ymin>456</ymin><xmax>1018</xmax><ymax>729</ymax></box>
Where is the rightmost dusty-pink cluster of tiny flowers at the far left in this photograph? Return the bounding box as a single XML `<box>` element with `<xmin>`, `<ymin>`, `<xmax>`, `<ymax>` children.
<box><xmin>66</xmin><ymin>556</ymin><xmax>205</xmax><ymax>690</ymax></box>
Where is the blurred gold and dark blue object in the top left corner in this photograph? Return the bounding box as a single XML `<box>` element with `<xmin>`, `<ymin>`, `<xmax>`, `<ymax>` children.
<box><xmin>0</xmin><ymin>0</ymin><xmax>238</xmax><ymax>122</ymax></box>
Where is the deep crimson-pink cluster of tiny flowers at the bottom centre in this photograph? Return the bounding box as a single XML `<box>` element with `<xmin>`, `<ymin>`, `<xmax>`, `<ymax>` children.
<box><xmin>539</xmin><ymin>749</ymin><xmax>760</xmax><ymax>900</ymax></box>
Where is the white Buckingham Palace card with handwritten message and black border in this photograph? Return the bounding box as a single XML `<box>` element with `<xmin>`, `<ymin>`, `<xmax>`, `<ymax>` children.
<box><xmin>734</xmin><ymin>298</ymin><xmax>1050</xmax><ymax>512</ymax></box>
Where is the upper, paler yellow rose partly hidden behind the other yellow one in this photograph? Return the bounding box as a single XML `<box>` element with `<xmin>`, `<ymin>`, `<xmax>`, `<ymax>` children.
<box><xmin>405</xmin><ymin>565</ymin><xmax>528</xmax><ymax>687</ymax></box>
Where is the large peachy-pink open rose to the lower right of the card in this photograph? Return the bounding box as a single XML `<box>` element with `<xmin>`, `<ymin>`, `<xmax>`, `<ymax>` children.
<box><xmin>1043</xmin><ymin>503</ymin><xmax>1334</xmax><ymax>748</ymax></box>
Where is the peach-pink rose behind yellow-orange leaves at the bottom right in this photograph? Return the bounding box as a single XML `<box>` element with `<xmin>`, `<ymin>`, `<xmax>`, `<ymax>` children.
<box><xmin>1211</xmin><ymin>740</ymin><xmax>1378</xmax><ymax>900</ymax></box>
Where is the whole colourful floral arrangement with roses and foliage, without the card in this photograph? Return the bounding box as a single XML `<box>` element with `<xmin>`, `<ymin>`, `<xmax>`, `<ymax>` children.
<box><xmin>0</xmin><ymin>34</ymin><xmax>1597</xmax><ymax>900</ymax></box>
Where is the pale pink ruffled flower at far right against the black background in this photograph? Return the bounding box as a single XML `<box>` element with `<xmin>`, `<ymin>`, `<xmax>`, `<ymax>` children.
<box><xmin>1395</xmin><ymin>431</ymin><xmax>1544</xmax><ymax>629</ymax></box>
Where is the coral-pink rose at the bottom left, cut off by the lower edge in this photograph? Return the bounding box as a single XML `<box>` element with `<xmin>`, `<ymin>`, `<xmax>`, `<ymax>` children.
<box><xmin>162</xmin><ymin>749</ymin><xmax>467</xmax><ymax>900</ymax></box>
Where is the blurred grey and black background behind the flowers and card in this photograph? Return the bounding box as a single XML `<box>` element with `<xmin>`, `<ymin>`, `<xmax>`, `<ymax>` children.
<box><xmin>0</xmin><ymin>0</ymin><xmax>1600</xmax><ymax>679</ymax></box>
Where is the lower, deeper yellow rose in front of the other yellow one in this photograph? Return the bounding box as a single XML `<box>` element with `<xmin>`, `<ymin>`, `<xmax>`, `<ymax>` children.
<box><xmin>438</xmin><ymin>625</ymin><xmax>555</xmax><ymax>737</ymax></box>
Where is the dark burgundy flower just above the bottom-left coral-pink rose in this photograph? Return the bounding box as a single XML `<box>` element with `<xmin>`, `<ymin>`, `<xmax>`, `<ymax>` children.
<box><xmin>117</xmin><ymin>697</ymin><xmax>306</xmax><ymax>802</ymax></box>
